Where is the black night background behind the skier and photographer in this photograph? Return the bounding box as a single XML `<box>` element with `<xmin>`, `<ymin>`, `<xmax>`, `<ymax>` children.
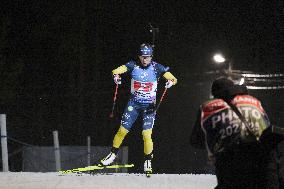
<box><xmin>0</xmin><ymin>0</ymin><xmax>284</xmax><ymax>173</ymax></box>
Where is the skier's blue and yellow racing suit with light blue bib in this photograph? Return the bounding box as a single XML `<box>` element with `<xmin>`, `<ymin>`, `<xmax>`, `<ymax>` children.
<box><xmin>112</xmin><ymin>61</ymin><xmax>177</xmax><ymax>155</ymax></box>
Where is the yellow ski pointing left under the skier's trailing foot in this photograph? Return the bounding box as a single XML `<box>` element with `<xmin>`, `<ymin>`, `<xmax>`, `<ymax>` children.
<box><xmin>59</xmin><ymin>164</ymin><xmax>134</xmax><ymax>174</ymax></box>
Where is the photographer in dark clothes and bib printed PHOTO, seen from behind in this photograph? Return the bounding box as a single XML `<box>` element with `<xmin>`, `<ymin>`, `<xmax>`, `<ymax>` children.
<box><xmin>190</xmin><ymin>77</ymin><xmax>270</xmax><ymax>189</ymax></box>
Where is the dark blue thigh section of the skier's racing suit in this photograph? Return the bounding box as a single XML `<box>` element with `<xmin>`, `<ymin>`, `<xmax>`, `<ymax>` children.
<box><xmin>121</xmin><ymin>99</ymin><xmax>156</xmax><ymax>131</ymax></box>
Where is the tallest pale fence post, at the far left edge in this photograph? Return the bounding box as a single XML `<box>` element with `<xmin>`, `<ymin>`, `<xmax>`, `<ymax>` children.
<box><xmin>0</xmin><ymin>114</ymin><xmax>9</xmax><ymax>172</ymax></box>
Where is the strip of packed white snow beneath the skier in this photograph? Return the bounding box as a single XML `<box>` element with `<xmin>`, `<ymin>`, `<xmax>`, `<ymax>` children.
<box><xmin>0</xmin><ymin>172</ymin><xmax>216</xmax><ymax>189</ymax></box>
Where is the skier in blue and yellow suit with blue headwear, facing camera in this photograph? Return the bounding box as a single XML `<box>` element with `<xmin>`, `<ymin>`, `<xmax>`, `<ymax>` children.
<box><xmin>100</xmin><ymin>44</ymin><xmax>177</xmax><ymax>175</ymax></box>
